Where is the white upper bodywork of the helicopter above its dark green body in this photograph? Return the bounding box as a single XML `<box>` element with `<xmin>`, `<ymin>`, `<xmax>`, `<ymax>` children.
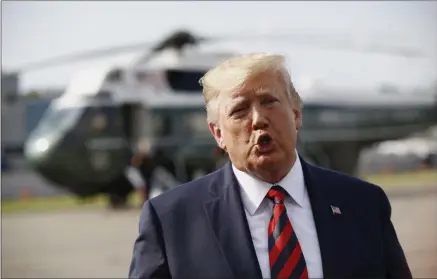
<box><xmin>47</xmin><ymin>39</ymin><xmax>436</xmax><ymax>110</ymax></box>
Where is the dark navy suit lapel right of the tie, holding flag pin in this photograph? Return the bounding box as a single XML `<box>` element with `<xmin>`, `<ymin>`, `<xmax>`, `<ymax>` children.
<box><xmin>301</xmin><ymin>158</ymin><xmax>353</xmax><ymax>278</ymax></box>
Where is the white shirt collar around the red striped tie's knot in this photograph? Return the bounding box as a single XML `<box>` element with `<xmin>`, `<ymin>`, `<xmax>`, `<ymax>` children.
<box><xmin>232</xmin><ymin>151</ymin><xmax>305</xmax><ymax>215</ymax></box>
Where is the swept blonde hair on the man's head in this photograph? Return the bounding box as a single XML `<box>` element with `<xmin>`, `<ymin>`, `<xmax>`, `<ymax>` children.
<box><xmin>199</xmin><ymin>53</ymin><xmax>302</xmax><ymax>122</ymax></box>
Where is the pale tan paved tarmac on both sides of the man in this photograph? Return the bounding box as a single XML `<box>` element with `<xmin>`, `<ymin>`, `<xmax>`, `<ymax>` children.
<box><xmin>2</xmin><ymin>194</ymin><xmax>437</xmax><ymax>278</ymax></box>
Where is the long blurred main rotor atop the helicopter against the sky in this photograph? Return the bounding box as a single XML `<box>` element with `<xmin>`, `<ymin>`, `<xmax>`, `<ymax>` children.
<box><xmin>17</xmin><ymin>30</ymin><xmax>425</xmax><ymax>73</ymax></box>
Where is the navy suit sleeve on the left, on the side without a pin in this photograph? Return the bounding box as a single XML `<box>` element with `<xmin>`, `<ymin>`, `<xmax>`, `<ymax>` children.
<box><xmin>129</xmin><ymin>201</ymin><xmax>171</xmax><ymax>278</ymax></box>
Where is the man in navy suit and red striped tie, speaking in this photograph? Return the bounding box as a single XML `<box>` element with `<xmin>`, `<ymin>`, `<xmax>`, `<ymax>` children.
<box><xmin>129</xmin><ymin>54</ymin><xmax>412</xmax><ymax>278</ymax></box>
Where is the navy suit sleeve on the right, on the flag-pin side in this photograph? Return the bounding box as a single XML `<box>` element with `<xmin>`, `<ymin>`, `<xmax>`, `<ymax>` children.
<box><xmin>381</xmin><ymin>189</ymin><xmax>412</xmax><ymax>279</ymax></box>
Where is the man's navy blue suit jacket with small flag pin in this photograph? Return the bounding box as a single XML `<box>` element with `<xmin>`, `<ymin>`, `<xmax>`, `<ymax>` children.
<box><xmin>129</xmin><ymin>160</ymin><xmax>412</xmax><ymax>278</ymax></box>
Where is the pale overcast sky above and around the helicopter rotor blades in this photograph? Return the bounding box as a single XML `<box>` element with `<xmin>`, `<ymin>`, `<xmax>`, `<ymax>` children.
<box><xmin>1</xmin><ymin>1</ymin><xmax>437</xmax><ymax>91</ymax></box>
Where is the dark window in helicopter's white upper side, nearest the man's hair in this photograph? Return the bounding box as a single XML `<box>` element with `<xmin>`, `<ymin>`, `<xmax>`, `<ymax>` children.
<box><xmin>166</xmin><ymin>69</ymin><xmax>205</xmax><ymax>93</ymax></box>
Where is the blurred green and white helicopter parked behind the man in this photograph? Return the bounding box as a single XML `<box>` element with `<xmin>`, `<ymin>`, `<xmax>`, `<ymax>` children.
<box><xmin>21</xmin><ymin>30</ymin><xmax>437</xmax><ymax>207</ymax></box>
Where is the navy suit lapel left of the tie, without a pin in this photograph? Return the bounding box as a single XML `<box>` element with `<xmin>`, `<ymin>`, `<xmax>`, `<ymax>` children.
<box><xmin>204</xmin><ymin>163</ymin><xmax>262</xmax><ymax>278</ymax></box>
